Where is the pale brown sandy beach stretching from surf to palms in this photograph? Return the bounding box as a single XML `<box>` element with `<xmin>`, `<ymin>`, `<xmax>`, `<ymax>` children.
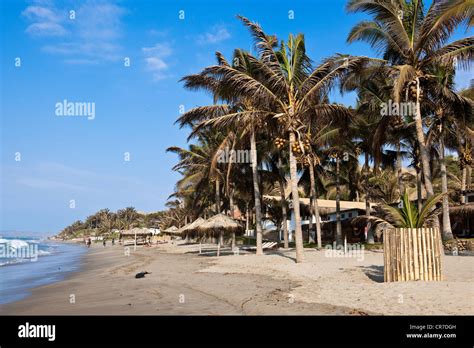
<box><xmin>0</xmin><ymin>244</ymin><xmax>474</xmax><ymax>315</ymax></box>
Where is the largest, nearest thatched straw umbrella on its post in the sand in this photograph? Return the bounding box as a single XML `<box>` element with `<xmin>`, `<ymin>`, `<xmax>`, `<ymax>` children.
<box><xmin>195</xmin><ymin>214</ymin><xmax>244</xmax><ymax>256</ymax></box>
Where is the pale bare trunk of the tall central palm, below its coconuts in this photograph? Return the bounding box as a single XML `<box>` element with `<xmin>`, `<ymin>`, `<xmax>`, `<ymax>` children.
<box><xmin>289</xmin><ymin>132</ymin><xmax>304</xmax><ymax>263</ymax></box>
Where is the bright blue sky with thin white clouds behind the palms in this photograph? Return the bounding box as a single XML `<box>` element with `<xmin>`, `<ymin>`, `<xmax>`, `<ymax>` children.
<box><xmin>0</xmin><ymin>0</ymin><xmax>469</xmax><ymax>233</ymax></box>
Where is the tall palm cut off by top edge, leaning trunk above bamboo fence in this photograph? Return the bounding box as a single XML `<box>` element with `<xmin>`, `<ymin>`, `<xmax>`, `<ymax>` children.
<box><xmin>347</xmin><ymin>0</ymin><xmax>474</xmax><ymax>196</ymax></box>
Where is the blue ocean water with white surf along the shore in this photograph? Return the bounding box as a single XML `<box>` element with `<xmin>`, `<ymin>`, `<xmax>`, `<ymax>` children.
<box><xmin>0</xmin><ymin>237</ymin><xmax>87</xmax><ymax>304</ymax></box>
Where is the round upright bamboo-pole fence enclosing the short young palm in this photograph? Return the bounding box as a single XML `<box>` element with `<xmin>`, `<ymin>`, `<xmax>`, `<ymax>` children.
<box><xmin>383</xmin><ymin>228</ymin><xmax>444</xmax><ymax>282</ymax></box>
